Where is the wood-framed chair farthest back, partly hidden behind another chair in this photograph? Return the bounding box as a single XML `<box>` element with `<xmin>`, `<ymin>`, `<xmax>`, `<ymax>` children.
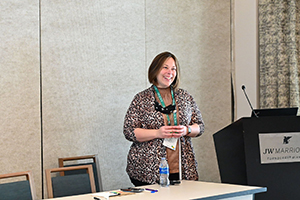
<box><xmin>58</xmin><ymin>155</ymin><xmax>103</xmax><ymax>192</ymax></box>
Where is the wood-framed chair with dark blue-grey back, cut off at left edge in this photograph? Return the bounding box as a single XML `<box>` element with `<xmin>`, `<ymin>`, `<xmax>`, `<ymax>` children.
<box><xmin>0</xmin><ymin>171</ymin><xmax>36</xmax><ymax>200</ymax></box>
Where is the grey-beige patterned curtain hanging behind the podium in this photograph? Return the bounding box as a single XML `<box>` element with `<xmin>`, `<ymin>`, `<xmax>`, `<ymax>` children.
<box><xmin>258</xmin><ymin>0</ymin><xmax>300</xmax><ymax>108</ymax></box>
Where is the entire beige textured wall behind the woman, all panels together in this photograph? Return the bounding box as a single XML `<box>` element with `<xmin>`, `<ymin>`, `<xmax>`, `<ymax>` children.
<box><xmin>0</xmin><ymin>0</ymin><xmax>231</xmax><ymax>198</ymax></box>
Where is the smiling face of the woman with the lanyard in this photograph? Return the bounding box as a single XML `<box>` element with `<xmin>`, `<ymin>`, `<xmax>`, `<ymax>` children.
<box><xmin>156</xmin><ymin>57</ymin><xmax>176</xmax><ymax>88</ymax></box>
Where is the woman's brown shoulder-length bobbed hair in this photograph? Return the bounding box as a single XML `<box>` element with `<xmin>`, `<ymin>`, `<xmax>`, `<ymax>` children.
<box><xmin>148</xmin><ymin>51</ymin><xmax>180</xmax><ymax>90</ymax></box>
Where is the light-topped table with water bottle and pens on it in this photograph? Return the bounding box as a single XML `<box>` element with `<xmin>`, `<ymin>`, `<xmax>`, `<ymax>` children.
<box><xmin>46</xmin><ymin>180</ymin><xmax>267</xmax><ymax>200</ymax></box>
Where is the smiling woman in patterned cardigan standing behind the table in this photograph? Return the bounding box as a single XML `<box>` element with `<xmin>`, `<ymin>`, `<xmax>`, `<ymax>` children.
<box><xmin>123</xmin><ymin>52</ymin><xmax>204</xmax><ymax>186</ymax></box>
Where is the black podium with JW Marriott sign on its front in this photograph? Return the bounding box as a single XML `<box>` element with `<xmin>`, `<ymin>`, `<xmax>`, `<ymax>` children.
<box><xmin>213</xmin><ymin>116</ymin><xmax>300</xmax><ymax>200</ymax></box>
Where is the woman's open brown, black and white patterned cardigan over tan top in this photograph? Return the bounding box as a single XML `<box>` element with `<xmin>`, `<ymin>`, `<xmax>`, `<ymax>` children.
<box><xmin>123</xmin><ymin>85</ymin><xmax>204</xmax><ymax>184</ymax></box>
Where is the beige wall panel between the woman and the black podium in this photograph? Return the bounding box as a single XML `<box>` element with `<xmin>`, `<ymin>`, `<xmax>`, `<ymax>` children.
<box><xmin>146</xmin><ymin>0</ymin><xmax>231</xmax><ymax>181</ymax></box>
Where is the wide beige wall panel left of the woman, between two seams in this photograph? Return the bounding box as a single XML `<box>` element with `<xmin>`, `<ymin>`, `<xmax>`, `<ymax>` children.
<box><xmin>41</xmin><ymin>0</ymin><xmax>146</xmax><ymax>195</ymax></box>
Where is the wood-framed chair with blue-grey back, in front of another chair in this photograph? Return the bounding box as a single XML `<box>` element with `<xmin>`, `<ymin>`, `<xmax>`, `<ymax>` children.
<box><xmin>45</xmin><ymin>165</ymin><xmax>96</xmax><ymax>198</ymax></box>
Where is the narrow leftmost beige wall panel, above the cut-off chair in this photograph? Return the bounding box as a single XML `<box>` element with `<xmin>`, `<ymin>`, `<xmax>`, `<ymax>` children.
<box><xmin>0</xmin><ymin>0</ymin><xmax>41</xmax><ymax>197</ymax></box>
